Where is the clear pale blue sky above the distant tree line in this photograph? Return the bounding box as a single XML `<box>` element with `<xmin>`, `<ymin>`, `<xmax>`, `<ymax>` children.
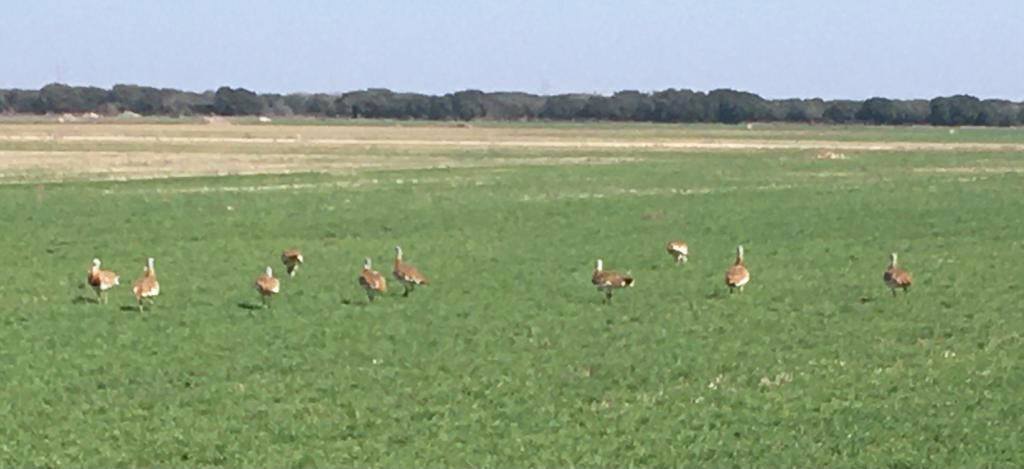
<box><xmin>0</xmin><ymin>0</ymin><xmax>1024</xmax><ymax>100</ymax></box>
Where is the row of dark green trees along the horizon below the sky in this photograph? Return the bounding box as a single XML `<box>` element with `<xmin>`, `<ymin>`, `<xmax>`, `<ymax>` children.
<box><xmin>0</xmin><ymin>83</ymin><xmax>1024</xmax><ymax>126</ymax></box>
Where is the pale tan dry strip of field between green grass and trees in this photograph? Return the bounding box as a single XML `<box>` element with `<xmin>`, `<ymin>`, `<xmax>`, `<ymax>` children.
<box><xmin>0</xmin><ymin>123</ymin><xmax>1024</xmax><ymax>181</ymax></box>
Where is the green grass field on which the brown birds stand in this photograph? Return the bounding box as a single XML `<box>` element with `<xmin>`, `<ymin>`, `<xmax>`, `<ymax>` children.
<box><xmin>0</xmin><ymin>122</ymin><xmax>1024</xmax><ymax>467</ymax></box>
